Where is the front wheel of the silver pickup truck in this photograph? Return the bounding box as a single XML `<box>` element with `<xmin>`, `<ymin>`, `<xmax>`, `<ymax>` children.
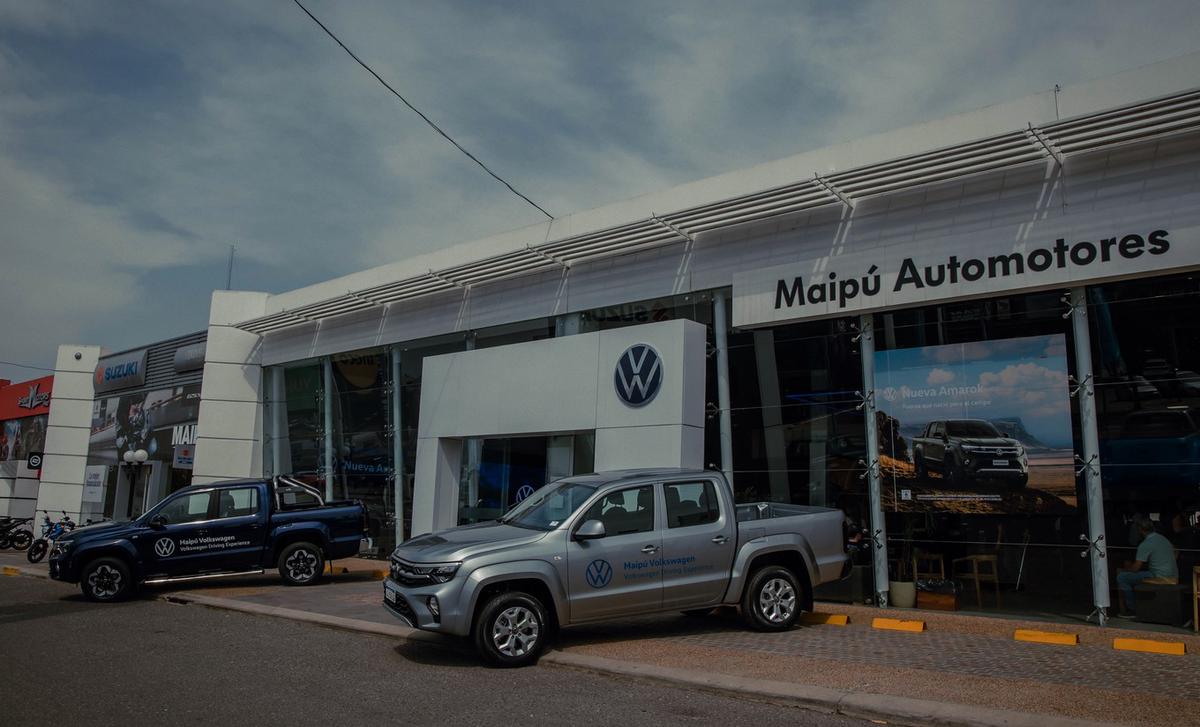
<box><xmin>472</xmin><ymin>590</ymin><xmax>548</xmax><ymax>667</ymax></box>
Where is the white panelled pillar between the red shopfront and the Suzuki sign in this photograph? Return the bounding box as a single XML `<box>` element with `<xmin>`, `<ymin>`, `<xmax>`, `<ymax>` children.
<box><xmin>34</xmin><ymin>344</ymin><xmax>100</xmax><ymax>523</ymax></box>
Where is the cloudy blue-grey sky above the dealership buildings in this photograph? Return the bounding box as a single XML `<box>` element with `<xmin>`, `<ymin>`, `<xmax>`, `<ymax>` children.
<box><xmin>0</xmin><ymin>0</ymin><xmax>1200</xmax><ymax>380</ymax></box>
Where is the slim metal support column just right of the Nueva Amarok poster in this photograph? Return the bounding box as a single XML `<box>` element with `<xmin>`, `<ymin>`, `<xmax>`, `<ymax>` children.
<box><xmin>1068</xmin><ymin>287</ymin><xmax>1111</xmax><ymax>626</ymax></box>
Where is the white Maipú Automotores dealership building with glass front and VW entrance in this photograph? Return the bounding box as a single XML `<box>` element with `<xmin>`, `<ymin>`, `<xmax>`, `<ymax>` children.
<box><xmin>37</xmin><ymin>55</ymin><xmax>1200</xmax><ymax>615</ymax></box>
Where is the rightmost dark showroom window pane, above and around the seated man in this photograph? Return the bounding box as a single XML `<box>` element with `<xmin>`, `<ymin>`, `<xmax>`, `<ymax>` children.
<box><xmin>1087</xmin><ymin>274</ymin><xmax>1200</xmax><ymax>626</ymax></box>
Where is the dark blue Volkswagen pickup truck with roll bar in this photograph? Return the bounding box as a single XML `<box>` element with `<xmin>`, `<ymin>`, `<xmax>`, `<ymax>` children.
<box><xmin>49</xmin><ymin>477</ymin><xmax>367</xmax><ymax>601</ymax></box>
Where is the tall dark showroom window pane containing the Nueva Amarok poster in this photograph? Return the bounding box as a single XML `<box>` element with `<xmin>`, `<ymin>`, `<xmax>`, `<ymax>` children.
<box><xmin>875</xmin><ymin>292</ymin><xmax>1092</xmax><ymax>618</ymax></box>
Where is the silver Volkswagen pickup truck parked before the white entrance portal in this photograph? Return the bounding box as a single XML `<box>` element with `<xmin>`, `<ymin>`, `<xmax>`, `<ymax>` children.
<box><xmin>384</xmin><ymin>469</ymin><xmax>850</xmax><ymax>666</ymax></box>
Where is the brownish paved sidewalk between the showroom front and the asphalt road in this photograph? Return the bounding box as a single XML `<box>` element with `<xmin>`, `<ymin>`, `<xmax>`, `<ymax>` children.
<box><xmin>0</xmin><ymin>557</ymin><xmax>1200</xmax><ymax>725</ymax></box>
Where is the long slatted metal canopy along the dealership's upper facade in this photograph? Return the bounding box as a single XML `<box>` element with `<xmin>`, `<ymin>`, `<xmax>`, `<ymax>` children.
<box><xmin>236</xmin><ymin>89</ymin><xmax>1200</xmax><ymax>335</ymax></box>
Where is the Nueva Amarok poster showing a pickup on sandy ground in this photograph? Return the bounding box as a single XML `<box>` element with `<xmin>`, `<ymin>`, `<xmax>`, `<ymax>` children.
<box><xmin>875</xmin><ymin>334</ymin><xmax>1078</xmax><ymax>515</ymax></box>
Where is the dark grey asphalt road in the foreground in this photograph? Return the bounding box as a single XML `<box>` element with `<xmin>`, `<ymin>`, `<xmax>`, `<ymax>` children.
<box><xmin>0</xmin><ymin>577</ymin><xmax>864</xmax><ymax>727</ymax></box>
